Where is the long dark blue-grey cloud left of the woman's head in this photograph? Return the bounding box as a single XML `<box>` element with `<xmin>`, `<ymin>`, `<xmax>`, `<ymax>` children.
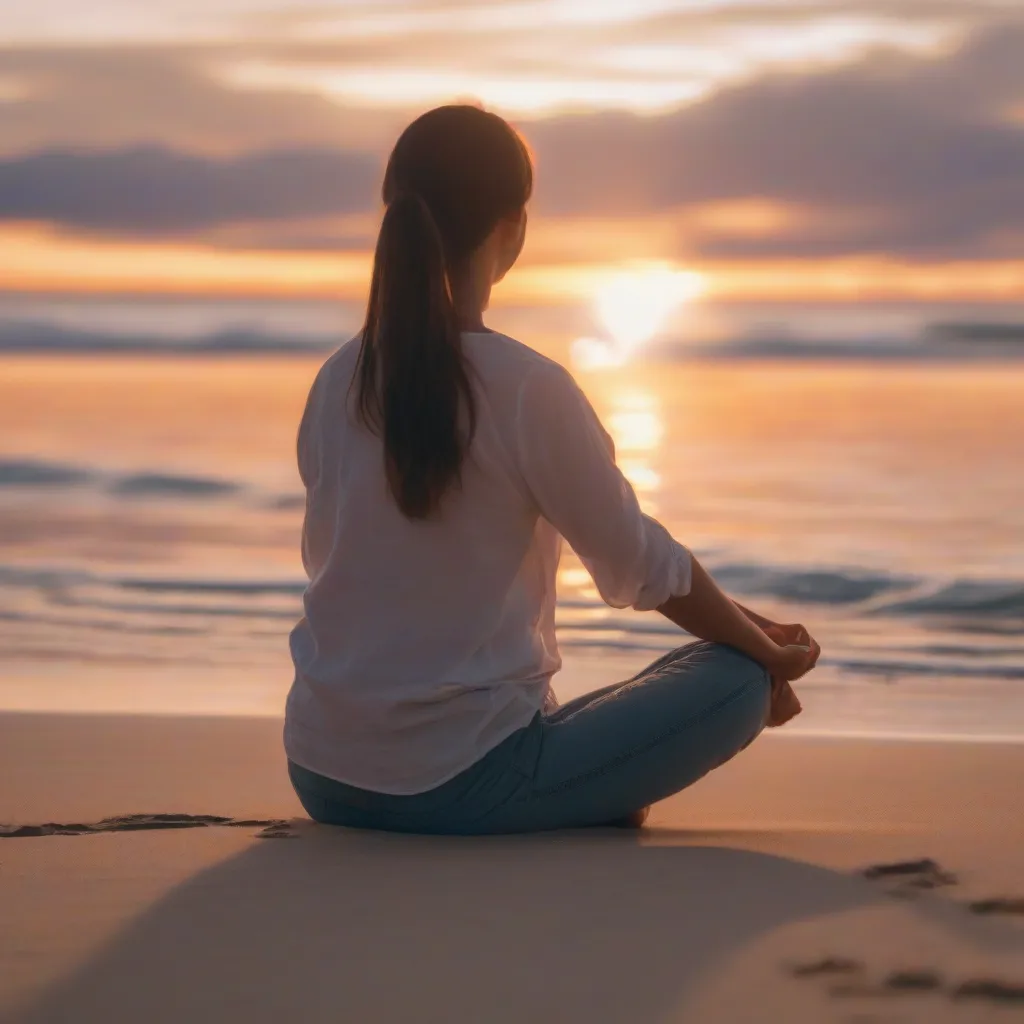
<box><xmin>0</xmin><ymin>147</ymin><xmax>380</xmax><ymax>234</ymax></box>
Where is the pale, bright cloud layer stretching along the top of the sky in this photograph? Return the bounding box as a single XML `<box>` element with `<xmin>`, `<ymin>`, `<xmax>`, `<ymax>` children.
<box><xmin>0</xmin><ymin>0</ymin><xmax>978</xmax><ymax>153</ymax></box>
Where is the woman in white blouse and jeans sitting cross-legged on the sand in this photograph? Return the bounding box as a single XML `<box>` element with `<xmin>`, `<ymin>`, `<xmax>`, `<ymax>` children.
<box><xmin>285</xmin><ymin>105</ymin><xmax>818</xmax><ymax>834</ymax></box>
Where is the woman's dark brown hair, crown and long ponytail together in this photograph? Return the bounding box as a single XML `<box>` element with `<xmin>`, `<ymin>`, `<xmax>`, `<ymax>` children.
<box><xmin>353</xmin><ymin>105</ymin><xmax>534</xmax><ymax>519</ymax></box>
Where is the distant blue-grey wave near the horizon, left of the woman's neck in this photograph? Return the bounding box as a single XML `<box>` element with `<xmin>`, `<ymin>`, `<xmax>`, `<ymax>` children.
<box><xmin>0</xmin><ymin>321</ymin><xmax>344</xmax><ymax>355</ymax></box>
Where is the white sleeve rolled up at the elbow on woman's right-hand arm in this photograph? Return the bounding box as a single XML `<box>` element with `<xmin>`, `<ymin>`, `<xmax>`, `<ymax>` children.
<box><xmin>517</xmin><ymin>364</ymin><xmax>690</xmax><ymax>611</ymax></box>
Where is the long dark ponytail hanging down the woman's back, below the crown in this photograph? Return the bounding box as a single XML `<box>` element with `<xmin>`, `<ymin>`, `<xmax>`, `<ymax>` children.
<box><xmin>353</xmin><ymin>191</ymin><xmax>476</xmax><ymax>519</ymax></box>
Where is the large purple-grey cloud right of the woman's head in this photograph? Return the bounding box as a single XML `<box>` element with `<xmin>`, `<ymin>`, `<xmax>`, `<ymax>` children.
<box><xmin>529</xmin><ymin>24</ymin><xmax>1024</xmax><ymax>256</ymax></box>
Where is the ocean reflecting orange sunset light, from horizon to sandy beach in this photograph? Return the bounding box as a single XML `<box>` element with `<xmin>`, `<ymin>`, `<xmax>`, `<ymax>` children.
<box><xmin>0</xmin><ymin>296</ymin><xmax>1024</xmax><ymax>740</ymax></box>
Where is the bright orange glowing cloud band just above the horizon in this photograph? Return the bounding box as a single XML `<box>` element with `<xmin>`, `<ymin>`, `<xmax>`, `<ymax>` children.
<box><xmin>0</xmin><ymin>220</ymin><xmax>1024</xmax><ymax>305</ymax></box>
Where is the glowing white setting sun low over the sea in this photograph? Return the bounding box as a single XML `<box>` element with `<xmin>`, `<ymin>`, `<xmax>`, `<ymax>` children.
<box><xmin>572</xmin><ymin>264</ymin><xmax>705</xmax><ymax>369</ymax></box>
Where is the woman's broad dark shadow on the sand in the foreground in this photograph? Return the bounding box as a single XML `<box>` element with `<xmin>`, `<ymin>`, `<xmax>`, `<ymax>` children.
<box><xmin>7</xmin><ymin>823</ymin><xmax>878</xmax><ymax>1024</ymax></box>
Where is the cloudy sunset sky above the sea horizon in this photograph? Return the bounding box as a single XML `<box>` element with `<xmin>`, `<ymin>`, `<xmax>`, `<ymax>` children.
<box><xmin>0</xmin><ymin>0</ymin><xmax>1024</xmax><ymax>302</ymax></box>
